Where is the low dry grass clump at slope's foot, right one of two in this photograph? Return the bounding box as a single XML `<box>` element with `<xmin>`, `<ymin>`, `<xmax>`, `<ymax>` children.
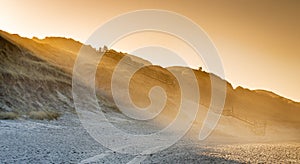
<box><xmin>28</xmin><ymin>111</ymin><xmax>60</xmax><ymax>120</ymax></box>
